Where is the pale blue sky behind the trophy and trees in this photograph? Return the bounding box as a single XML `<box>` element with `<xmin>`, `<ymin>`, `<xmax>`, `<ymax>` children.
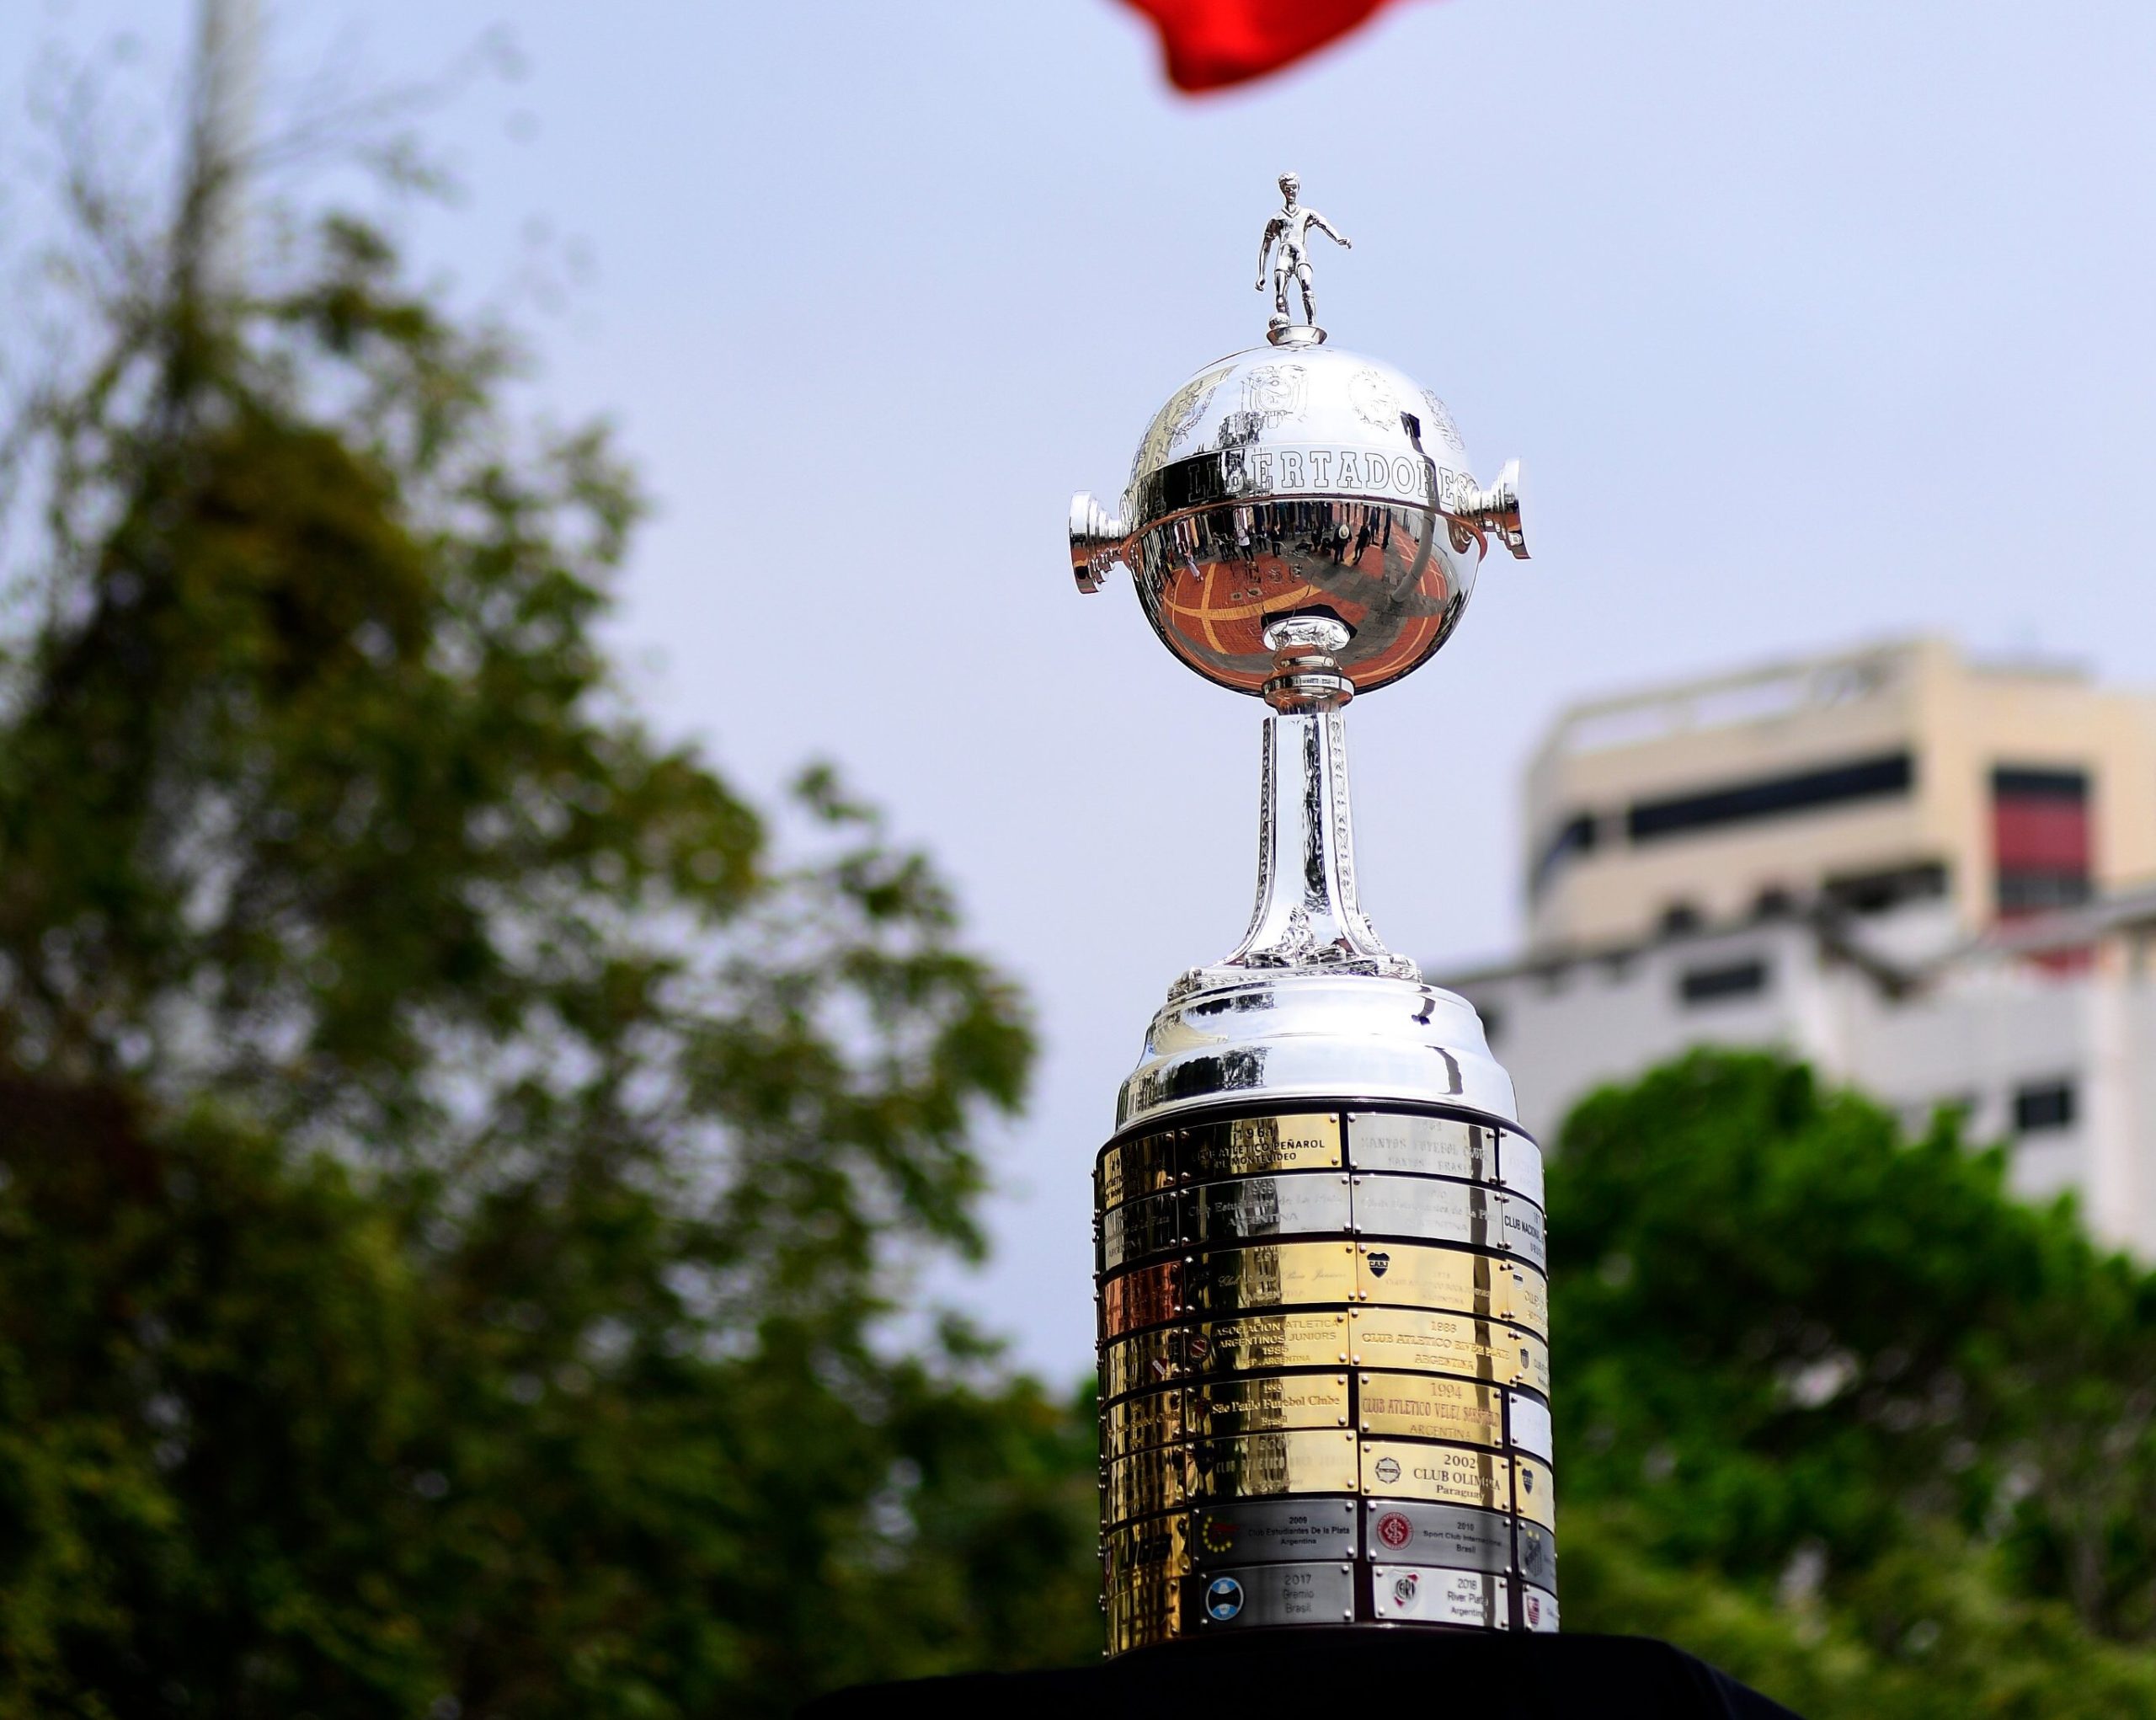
<box><xmin>0</xmin><ymin>0</ymin><xmax>2156</xmax><ymax>1375</ymax></box>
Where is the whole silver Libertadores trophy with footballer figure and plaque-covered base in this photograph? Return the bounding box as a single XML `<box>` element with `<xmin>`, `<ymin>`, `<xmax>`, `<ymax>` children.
<box><xmin>1070</xmin><ymin>174</ymin><xmax>1556</xmax><ymax>1655</ymax></box>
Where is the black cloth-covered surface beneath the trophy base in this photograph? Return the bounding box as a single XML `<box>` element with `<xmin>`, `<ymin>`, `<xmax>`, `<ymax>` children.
<box><xmin>800</xmin><ymin>1627</ymin><xmax>1796</xmax><ymax>1720</ymax></box>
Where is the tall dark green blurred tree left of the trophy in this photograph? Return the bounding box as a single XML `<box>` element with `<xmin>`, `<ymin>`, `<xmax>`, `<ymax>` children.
<box><xmin>0</xmin><ymin>114</ymin><xmax>1097</xmax><ymax>1720</ymax></box>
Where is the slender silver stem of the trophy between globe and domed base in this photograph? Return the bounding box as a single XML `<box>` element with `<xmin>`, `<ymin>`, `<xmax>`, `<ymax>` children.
<box><xmin>1179</xmin><ymin>709</ymin><xmax>1421</xmax><ymax>990</ymax></box>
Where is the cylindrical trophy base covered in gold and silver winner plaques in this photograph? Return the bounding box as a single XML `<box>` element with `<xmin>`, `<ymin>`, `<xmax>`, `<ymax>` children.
<box><xmin>1095</xmin><ymin>1110</ymin><xmax>1556</xmax><ymax>1653</ymax></box>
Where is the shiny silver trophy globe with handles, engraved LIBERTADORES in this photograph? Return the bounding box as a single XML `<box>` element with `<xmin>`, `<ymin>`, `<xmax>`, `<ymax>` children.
<box><xmin>1070</xmin><ymin>336</ymin><xmax>1526</xmax><ymax>694</ymax></box>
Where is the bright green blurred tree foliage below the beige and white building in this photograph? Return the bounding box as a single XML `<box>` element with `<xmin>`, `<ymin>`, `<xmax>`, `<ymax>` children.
<box><xmin>1550</xmin><ymin>1052</ymin><xmax>2156</xmax><ymax>1720</ymax></box>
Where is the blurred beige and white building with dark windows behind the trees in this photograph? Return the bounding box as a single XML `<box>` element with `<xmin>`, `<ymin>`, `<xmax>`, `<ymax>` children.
<box><xmin>1444</xmin><ymin>640</ymin><xmax>2156</xmax><ymax>1254</ymax></box>
